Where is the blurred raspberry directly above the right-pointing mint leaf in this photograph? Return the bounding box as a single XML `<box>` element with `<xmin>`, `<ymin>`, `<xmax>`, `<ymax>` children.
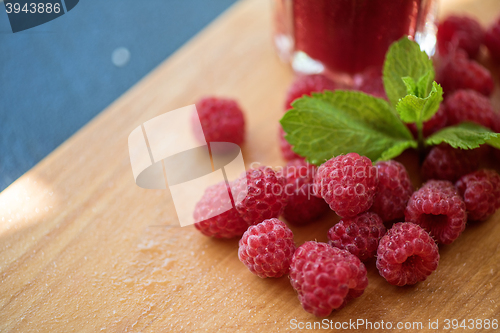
<box><xmin>445</xmin><ymin>90</ymin><xmax>496</xmax><ymax>128</ymax></box>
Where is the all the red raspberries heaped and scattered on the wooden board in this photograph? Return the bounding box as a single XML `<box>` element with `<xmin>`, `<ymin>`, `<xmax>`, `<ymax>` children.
<box><xmin>190</xmin><ymin>16</ymin><xmax>500</xmax><ymax>317</ymax></box>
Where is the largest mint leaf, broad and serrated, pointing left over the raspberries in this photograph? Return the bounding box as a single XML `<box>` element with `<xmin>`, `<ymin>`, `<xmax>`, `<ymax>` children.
<box><xmin>280</xmin><ymin>90</ymin><xmax>417</xmax><ymax>164</ymax></box>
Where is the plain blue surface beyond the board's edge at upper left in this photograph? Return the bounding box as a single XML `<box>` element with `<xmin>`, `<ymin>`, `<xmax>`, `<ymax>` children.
<box><xmin>0</xmin><ymin>0</ymin><xmax>236</xmax><ymax>191</ymax></box>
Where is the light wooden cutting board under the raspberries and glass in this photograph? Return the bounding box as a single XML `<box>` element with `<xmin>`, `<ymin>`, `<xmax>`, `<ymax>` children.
<box><xmin>0</xmin><ymin>0</ymin><xmax>500</xmax><ymax>332</ymax></box>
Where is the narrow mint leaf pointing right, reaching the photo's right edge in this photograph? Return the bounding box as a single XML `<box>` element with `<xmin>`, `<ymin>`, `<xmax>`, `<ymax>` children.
<box><xmin>425</xmin><ymin>123</ymin><xmax>500</xmax><ymax>149</ymax></box>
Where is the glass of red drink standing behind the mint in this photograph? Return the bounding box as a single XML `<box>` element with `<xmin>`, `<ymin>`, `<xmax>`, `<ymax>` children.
<box><xmin>274</xmin><ymin>0</ymin><xmax>437</xmax><ymax>84</ymax></box>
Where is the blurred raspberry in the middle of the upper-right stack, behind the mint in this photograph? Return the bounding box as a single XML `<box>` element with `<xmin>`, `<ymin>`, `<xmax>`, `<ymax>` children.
<box><xmin>436</xmin><ymin>50</ymin><xmax>495</xmax><ymax>96</ymax></box>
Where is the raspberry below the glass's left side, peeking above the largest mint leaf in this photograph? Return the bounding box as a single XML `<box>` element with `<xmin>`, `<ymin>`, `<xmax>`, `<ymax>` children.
<box><xmin>285</xmin><ymin>74</ymin><xmax>337</xmax><ymax>110</ymax></box>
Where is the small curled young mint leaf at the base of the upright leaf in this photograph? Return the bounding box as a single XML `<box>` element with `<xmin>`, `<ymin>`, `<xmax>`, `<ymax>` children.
<box><xmin>396</xmin><ymin>78</ymin><xmax>443</xmax><ymax>123</ymax></box>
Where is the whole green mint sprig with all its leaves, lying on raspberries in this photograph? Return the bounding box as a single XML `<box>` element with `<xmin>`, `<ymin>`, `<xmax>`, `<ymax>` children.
<box><xmin>280</xmin><ymin>37</ymin><xmax>500</xmax><ymax>164</ymax></box>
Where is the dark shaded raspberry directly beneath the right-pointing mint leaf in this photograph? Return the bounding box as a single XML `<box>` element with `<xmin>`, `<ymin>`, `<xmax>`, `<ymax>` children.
<box><xmin>421</xmin><ymin>144</ymin><xmax>479</xmax><ymax>182</ymax></box>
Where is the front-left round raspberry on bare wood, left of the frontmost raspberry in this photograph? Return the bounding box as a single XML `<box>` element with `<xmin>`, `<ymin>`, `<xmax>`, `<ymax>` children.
<box><xmin>238</xmin><ymin>219</ymin><xmax>295</xmax><ymax>278</ymax></box>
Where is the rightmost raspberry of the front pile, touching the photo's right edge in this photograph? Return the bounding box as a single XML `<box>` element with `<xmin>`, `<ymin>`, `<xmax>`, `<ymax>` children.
<box><xmin>456</xmin><ymin>169</ymin><xmax>500</xmax><ymax>221</ymax></box>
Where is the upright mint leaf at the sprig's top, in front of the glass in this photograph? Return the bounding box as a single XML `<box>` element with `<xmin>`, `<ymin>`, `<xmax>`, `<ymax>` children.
<box><xmin>383</xmin><ymin>37</ymin><xmax>435</xmax><ymax>106</ymax></box>
